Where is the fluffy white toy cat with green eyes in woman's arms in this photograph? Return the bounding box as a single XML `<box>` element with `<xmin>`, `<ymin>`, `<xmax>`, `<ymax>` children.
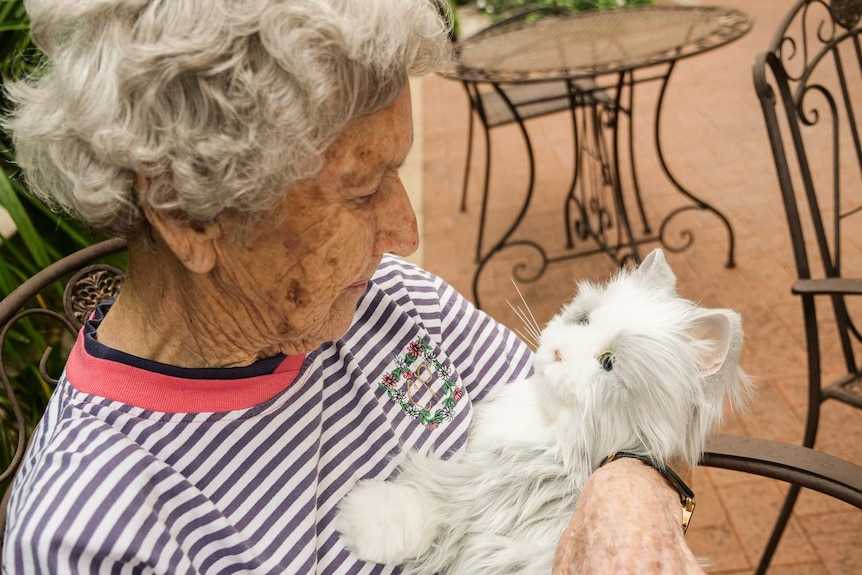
<box><xmin>336</xmin><ymin>250</ymin><xmax>749</xmax><ymax>575</ymax></box>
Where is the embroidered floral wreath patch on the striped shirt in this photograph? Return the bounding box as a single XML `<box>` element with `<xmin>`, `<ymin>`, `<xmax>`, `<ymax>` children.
<box><xmin>378</xmin><ymin>337</ymin><xmax>463</xmax><ymax>429</ymax></box>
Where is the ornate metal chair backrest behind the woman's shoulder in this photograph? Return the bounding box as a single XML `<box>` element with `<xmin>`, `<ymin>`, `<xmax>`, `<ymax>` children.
<box><xmin>0</xmin><ymin>239</ymin><xmax>126</xmax><ymax>541</ymax></box>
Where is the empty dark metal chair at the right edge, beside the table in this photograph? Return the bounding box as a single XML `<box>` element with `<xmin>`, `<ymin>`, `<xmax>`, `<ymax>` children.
<box><xmin>754</xmin><ymin>0</ymin><xmax>862</xmax><ymax>573</ymax></box>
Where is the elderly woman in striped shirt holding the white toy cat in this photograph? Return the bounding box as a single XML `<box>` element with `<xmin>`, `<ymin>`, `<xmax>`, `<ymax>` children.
<box><xmin>3</xmin><ymin>0</ymin><xmax>708</xmax><ymax>574</ymax></box>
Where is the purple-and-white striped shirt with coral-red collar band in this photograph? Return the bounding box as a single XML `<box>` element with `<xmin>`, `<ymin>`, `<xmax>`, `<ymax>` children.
<box><xmin>3</xmin><ymin>257</ymin><xmax>531</xmax><ymax>574</ymax></box>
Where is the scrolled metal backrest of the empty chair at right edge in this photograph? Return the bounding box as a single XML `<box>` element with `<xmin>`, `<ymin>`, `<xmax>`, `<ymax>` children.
<box><xmin>754</xmin><ymin>0</ymin><xmax>862</xmax><ymax>372</ymax></box>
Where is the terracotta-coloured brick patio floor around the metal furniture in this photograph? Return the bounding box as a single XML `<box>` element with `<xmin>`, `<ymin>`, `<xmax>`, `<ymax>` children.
<box><xmin>416</xmin><ymin>0</ymin><xmax>862</xmax><ymax>575</ymax></box>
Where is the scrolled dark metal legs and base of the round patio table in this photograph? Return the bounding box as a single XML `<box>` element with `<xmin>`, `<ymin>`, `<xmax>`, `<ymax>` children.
<box><xmin>473</xmin><ymin>59</ymin><xmax>734</xmax><ymax>307</ymax></box>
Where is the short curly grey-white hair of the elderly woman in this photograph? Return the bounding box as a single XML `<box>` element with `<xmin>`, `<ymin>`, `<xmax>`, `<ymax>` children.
<box><xmin>4</xmin><ymin>0</ymin><xmax>450</xmax><ymax>236</ymax></box>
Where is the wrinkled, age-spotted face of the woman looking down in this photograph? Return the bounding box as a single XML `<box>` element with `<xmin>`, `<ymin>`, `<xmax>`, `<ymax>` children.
<box><xmin>215</xmin><ymin>88</ymin><xmax>419</xmax><ymax>354</ymax></box>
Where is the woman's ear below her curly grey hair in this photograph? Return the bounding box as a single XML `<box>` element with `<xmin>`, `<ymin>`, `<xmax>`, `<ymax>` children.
<box><xmin>135</xmin><ymin>175</ymin><xmax>221</xmax><ymax>274</ymax></box>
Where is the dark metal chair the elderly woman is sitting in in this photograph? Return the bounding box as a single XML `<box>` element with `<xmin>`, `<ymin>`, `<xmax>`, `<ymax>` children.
<box><xmin>0</xmin><ymin>239</ymin><xmax>862</xmax><ymax>560</ymax></box>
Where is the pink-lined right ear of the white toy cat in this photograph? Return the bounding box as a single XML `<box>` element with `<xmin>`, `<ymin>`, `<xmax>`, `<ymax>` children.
<box><xmin>689</xmin><ymin>309</ymin><xmax>742</xmax><ymax>377</ymax></box>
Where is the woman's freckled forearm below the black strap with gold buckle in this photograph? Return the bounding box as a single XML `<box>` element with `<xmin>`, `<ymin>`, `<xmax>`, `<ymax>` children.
<box><xmin>553</xmin><ymin>459</ymin><xmax>704</xmax><ymax>575</ymax></box>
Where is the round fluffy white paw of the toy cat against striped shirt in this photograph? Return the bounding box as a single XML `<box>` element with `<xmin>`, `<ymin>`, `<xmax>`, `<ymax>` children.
<box><xmin>335</xmin><ymin>481</ymin><xmax>436</xmax><ymax>565</ymax></box>
